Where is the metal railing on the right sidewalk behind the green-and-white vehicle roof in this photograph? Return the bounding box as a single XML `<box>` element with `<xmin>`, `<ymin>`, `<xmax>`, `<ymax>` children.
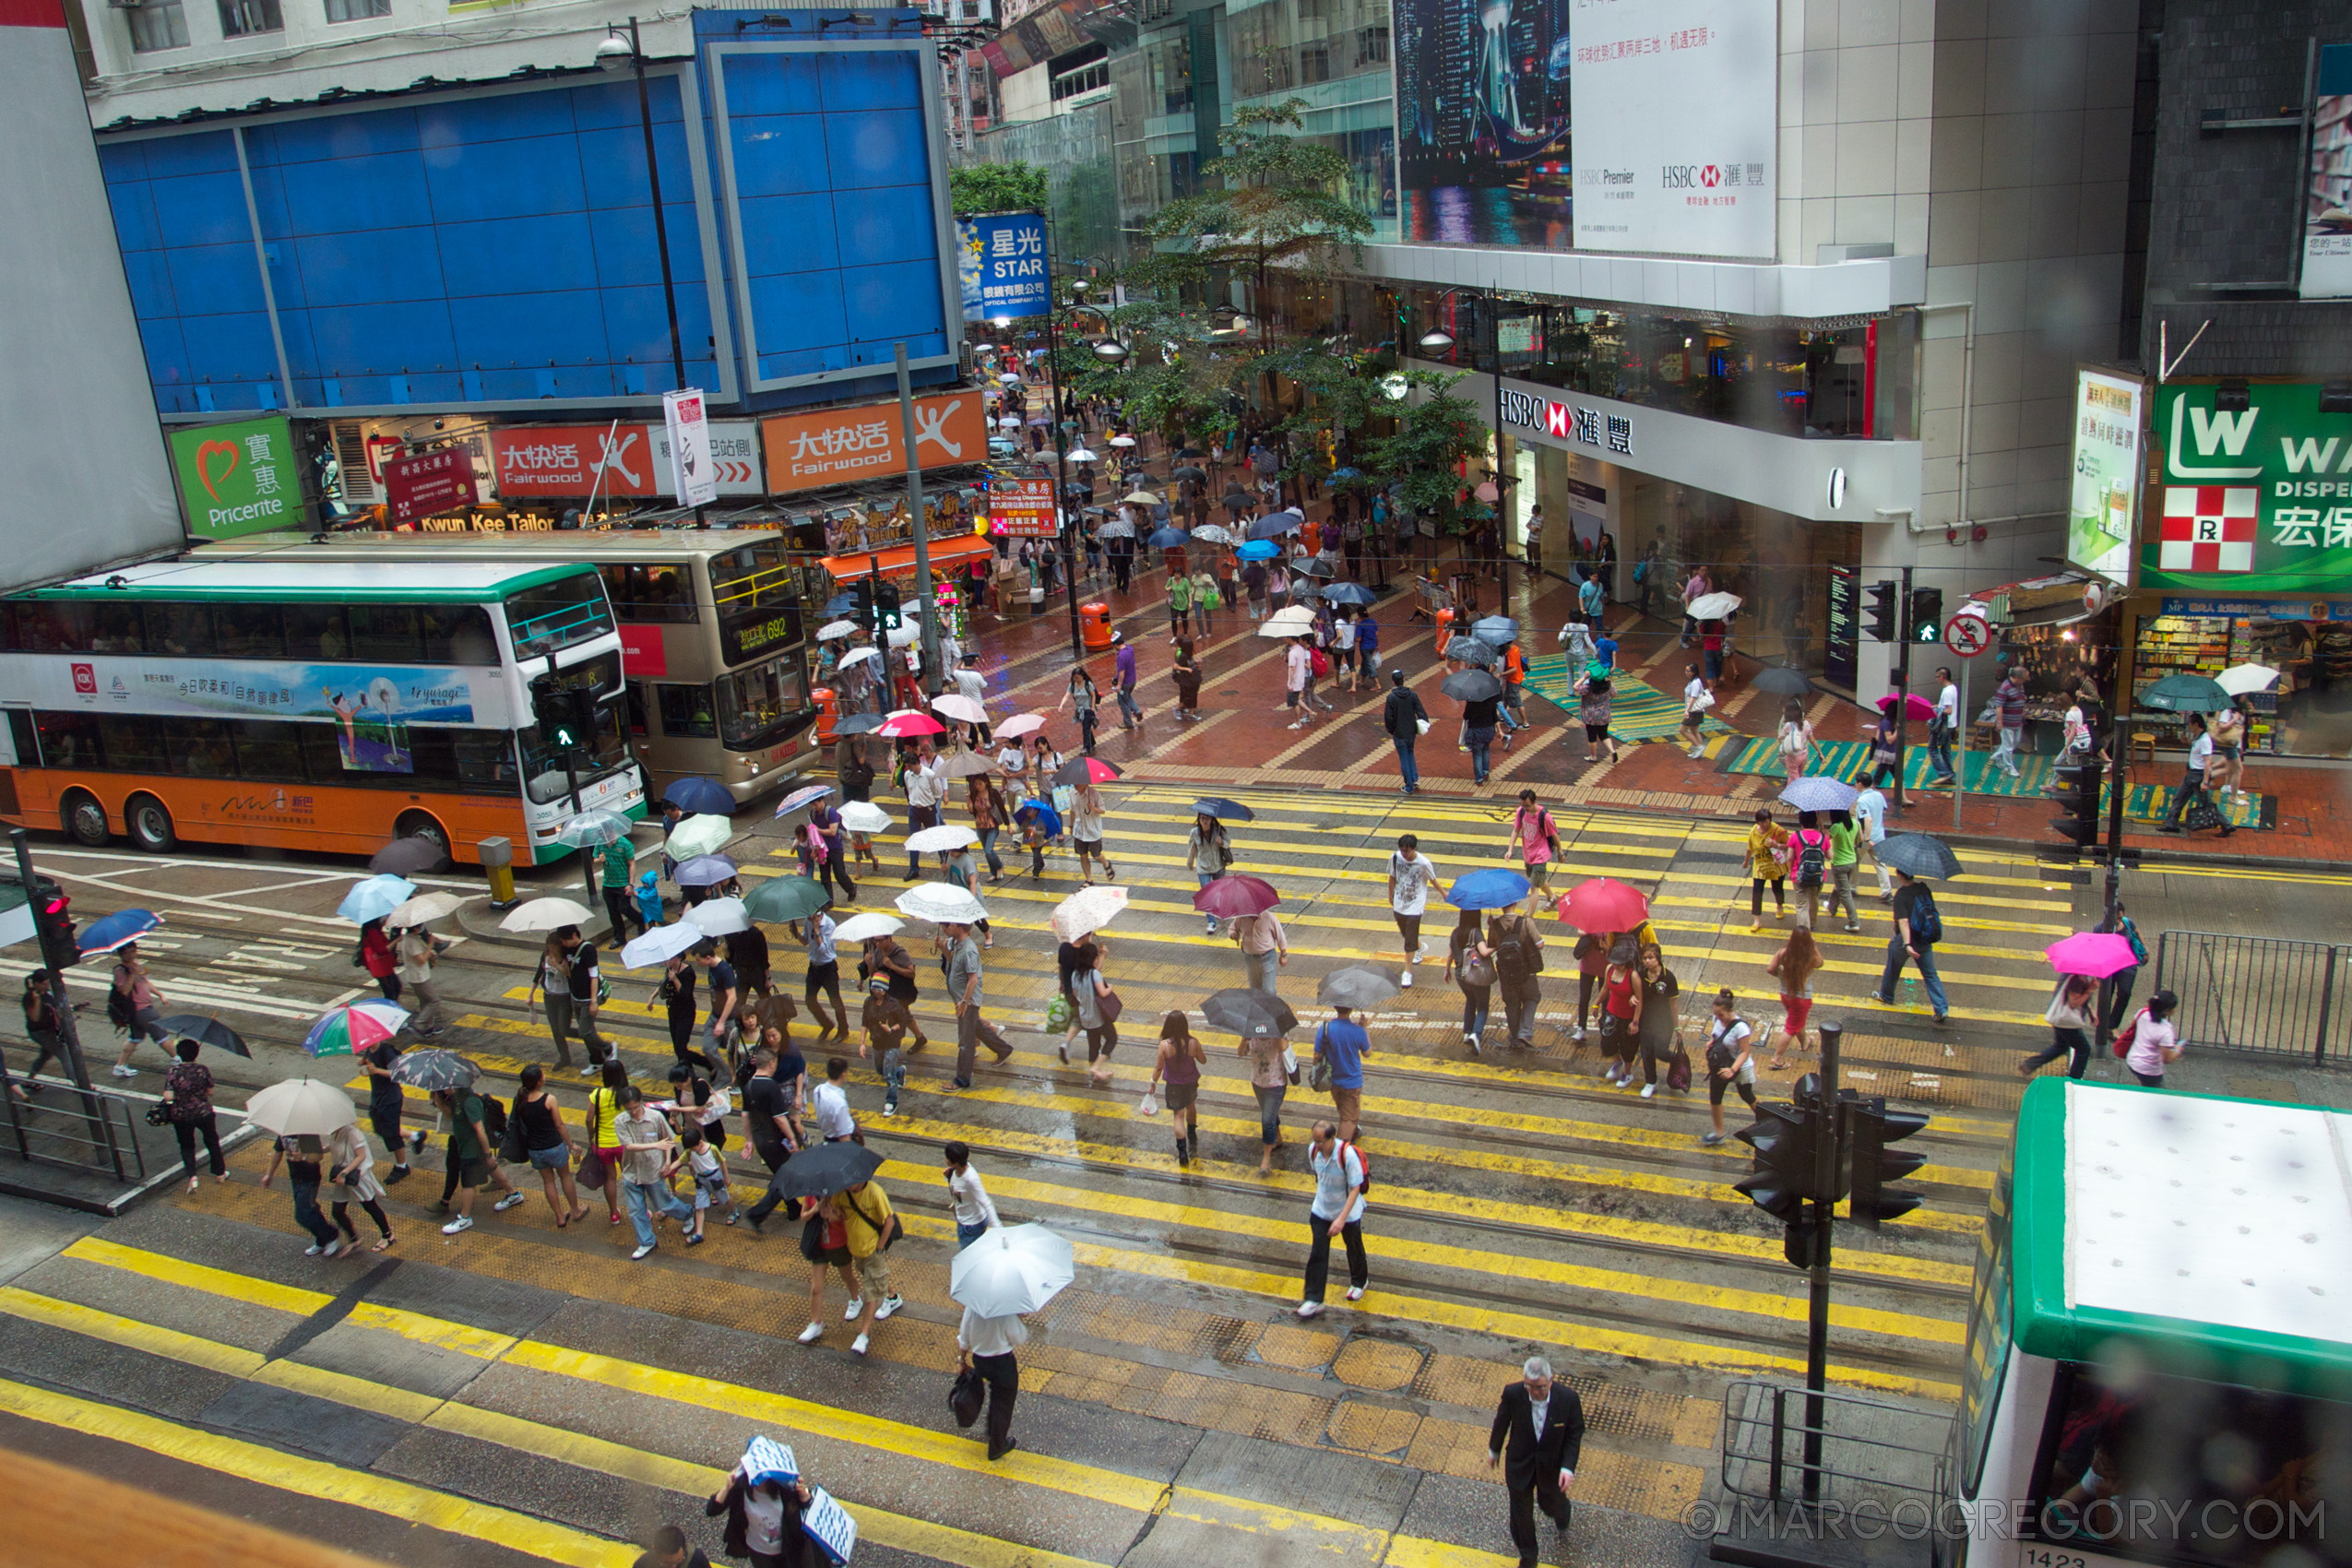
<box><xmin>2143</xmin><ymin>931</ymin><xmax>2352</xmax><ymax>1067</ymax></box>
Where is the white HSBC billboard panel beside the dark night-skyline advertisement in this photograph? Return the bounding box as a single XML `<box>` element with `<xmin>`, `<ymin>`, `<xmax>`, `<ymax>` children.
<box><xmin>1569</xmin><ymin>0</ymin><xmax>1780</xmax><ymax>258</ymax></box>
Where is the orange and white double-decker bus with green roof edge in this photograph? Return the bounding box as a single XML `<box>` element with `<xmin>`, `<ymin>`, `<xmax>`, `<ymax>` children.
<box><xmin>0</xmin><ymin>552</ymin><xmax>645</xmax><ymax>865</ymax></box>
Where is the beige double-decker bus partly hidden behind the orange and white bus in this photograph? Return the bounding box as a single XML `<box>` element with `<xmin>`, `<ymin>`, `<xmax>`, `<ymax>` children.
<box><xmin>202</xmin><ymin>529</ymin><xmax>821</xmax><ymax>802</ymax></box>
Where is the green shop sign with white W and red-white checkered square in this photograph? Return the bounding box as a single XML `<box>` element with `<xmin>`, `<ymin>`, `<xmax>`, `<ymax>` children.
<box><xmin>2141</xmin><ymin>381</ymin><xmax>2352</xmax><ymax>592</ymax></box>
